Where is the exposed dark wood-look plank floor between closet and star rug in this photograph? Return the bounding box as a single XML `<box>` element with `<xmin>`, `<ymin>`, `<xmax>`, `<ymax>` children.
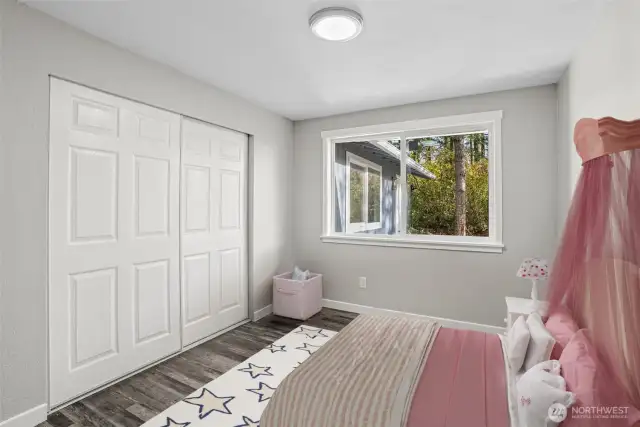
<box><xmin>38</xmin><ymin>308</ymin><xmax>357</xmax><ymax>427</ymax></box>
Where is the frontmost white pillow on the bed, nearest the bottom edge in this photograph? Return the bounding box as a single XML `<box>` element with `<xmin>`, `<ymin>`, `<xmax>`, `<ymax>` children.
<box><xmin>518</xmin><ymin>360</ymin><xmax>576</xmax><ymax>427</ymax></box>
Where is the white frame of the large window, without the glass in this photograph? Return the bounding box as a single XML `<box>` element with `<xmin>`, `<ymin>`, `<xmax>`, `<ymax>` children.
<box><xmin>321</xmin><ymin>111</ymin><xmax>504</xmax><ymax>253</ymax></box>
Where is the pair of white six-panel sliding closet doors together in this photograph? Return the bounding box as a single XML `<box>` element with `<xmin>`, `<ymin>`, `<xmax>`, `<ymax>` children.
<box><xmin>49</xmin><ymin>78</ymin><xmax>247</xmax><ymax>407</ymax></box>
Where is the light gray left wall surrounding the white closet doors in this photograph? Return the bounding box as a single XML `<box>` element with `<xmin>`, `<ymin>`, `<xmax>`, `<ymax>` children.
<box><xmin>0</xmin><ymin>0</ymin><xmax>293</xmax><ymax>419</ymax></box>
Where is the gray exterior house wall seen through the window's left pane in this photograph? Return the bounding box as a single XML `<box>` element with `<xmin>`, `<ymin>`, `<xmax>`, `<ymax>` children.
<box><xmin>334</xmin><ymin>143</ymin><xmax>400</xmax><ymax>234</ymax></box>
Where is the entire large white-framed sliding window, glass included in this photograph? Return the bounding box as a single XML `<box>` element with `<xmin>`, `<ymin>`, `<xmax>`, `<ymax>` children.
<box><xmin>322</xmin><ymin>111</ymin><xmax>503</xmax><ymax>252</ymax></box>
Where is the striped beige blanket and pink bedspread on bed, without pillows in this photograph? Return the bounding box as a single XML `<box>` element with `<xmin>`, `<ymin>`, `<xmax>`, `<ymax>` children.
<box><xmin>260</xmin><ymin>315</ymin><xmax>517</xmax><ymax>427</ymax></box>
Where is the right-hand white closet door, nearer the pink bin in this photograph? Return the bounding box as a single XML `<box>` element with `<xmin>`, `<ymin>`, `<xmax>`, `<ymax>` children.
<box><xmin>181</xmin><ymin>118</ymin><xmax>248</xmax><ymax>345</ymax></box>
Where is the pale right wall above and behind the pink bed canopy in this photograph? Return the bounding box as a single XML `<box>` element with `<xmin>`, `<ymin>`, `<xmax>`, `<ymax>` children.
<box><xmin>557</xmin><ymin>0</ymin><xmax>640</xmax><ymax>228</ymax></box>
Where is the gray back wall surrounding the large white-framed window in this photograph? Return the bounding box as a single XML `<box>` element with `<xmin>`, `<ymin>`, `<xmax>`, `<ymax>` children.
<box><xmin>293</xmin><ymin>85</ymin><xmax>557</xmax><ymax>326</ymax></box>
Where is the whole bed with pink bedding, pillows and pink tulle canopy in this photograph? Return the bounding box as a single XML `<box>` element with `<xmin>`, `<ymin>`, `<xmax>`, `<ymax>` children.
<box><xmin>260</xmin><ymin>117</ymin><xmax>640</xmax><ymax>427</ymax></box>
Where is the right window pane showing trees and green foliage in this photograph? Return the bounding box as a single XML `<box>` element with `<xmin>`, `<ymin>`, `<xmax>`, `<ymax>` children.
<box><xmin>406</xmin><ymin>132</ymin><xmax>489</xmax><ymax>236</ymax></box>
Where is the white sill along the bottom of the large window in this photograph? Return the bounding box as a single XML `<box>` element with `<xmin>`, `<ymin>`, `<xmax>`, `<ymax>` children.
<box><xmin>320</xmin><ymin>235</ymin><xmax>504</xmax><ymax>254</ymax></box>
